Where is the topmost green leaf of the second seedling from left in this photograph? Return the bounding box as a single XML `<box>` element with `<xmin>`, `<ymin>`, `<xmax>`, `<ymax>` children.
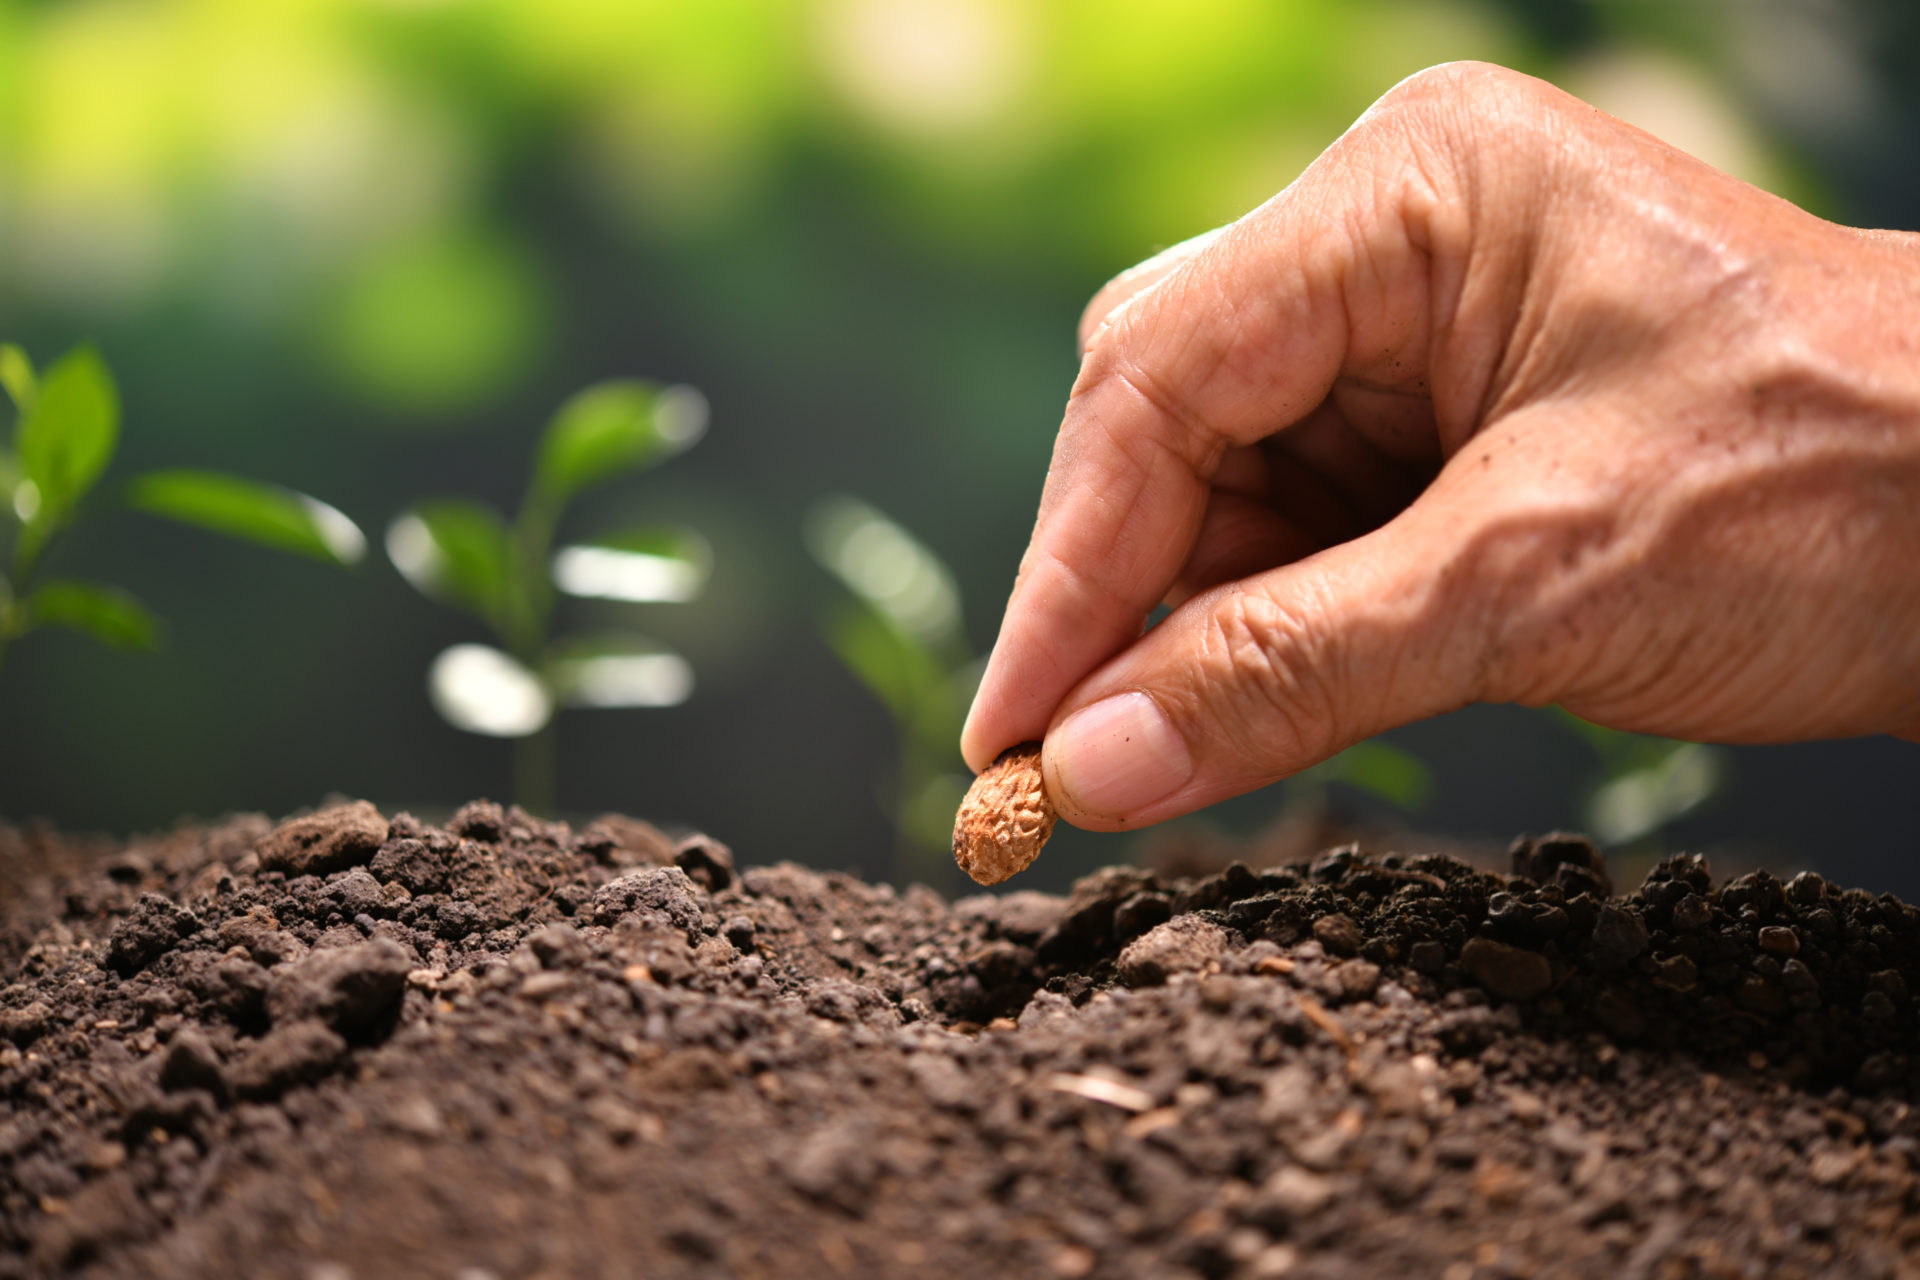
<box><xmin>534</xmin><ymin>378</ymin><xmax>707</xmax><ymax>503</ymax></box>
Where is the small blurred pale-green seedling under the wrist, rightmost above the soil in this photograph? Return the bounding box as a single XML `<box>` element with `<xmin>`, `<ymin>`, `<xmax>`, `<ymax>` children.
<box><xmin>1553</xmin><ymin>706</ymin><xmax>1732</xmax><ymax>844</ymax></box>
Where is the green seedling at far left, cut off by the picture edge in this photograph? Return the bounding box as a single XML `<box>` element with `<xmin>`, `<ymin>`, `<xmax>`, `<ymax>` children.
<box><xmin>0</xmin><ymin>345</ymin><xmax>367</xmax><ymax>679</ymax></box>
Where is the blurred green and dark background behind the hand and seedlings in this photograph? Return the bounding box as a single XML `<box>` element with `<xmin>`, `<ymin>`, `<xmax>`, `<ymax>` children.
<box><xmin>0</xmin><ymin>0</ymin><xmax>1920</xmax><ymax>896</ymax></box>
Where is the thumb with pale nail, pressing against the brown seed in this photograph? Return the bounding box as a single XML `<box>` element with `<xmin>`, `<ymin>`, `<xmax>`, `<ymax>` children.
<box><xmin>1043</xmin><ymin>503</ymin><xmax>1490</xmax><ymax>831</ymax></box>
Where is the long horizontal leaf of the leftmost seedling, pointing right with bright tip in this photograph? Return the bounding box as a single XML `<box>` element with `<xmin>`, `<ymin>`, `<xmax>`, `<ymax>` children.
<box><xmin>127</xmin><ymin>468</ymin><xmax>367</xmax><ymax>564</ymax></box>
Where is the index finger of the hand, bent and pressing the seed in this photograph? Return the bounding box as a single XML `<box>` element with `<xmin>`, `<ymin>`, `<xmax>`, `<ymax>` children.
<box><xmin>962</xmin><ymin>82</ymin><xmax>1446</xmax><ymax>782</ymax></box>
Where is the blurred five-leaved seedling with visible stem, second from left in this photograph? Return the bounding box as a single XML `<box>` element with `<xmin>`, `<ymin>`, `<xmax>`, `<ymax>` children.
<box><xmin>386</xmin><ymin>380</ymin><xmax>710</xmax><ymax>812</ymax></box>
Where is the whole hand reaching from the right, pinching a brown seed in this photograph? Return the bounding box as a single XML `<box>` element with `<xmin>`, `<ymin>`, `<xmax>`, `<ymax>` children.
<box><xmin>962</xmin><ymin>65</ymin><xmax>1920</xmax><ymax>829</ymax></box>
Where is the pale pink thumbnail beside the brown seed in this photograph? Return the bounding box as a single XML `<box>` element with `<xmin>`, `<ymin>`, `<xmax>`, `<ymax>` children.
<box><xmin>1048</xmin><ymin>693</ymin><xmax>1194</xmax><ymax>818</ymax></box>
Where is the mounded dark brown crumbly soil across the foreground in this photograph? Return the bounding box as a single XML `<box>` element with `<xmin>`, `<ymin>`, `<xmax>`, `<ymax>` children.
<box><xmin>0</xmin><ymin>802</ymin><xmax>1920</xmax><ymax>1280</ymax></box>
